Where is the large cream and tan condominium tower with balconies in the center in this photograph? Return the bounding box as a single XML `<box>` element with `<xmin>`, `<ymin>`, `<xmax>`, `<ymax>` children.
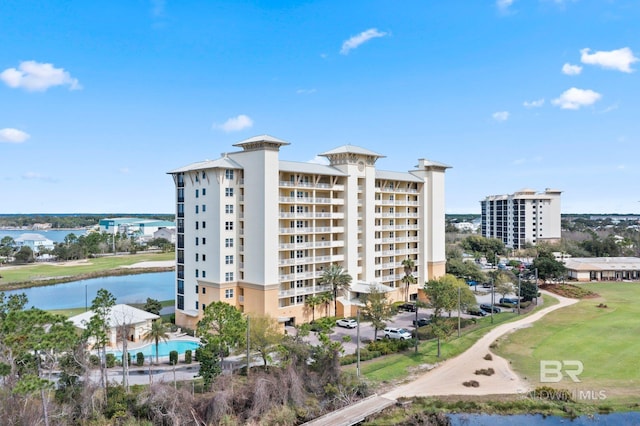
<box><xmin>169</xmin><ymin>136</ymin><xmax>448</xmax><ymax>327</ymax></box>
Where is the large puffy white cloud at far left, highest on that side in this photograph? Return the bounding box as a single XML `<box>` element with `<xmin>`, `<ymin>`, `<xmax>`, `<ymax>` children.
<box><xmin>0</xmin><ymin>61</ymin><xmax>82</xmax><ymax>92</ymax></box>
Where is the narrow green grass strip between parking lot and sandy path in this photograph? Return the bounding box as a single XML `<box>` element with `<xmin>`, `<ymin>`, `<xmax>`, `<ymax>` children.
<box><xmin>344</xmin><ymin>296</ymin><xmax>558</xmax><ymax>384</ymax></box>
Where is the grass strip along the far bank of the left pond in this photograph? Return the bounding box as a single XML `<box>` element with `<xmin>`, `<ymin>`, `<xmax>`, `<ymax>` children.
<box><xmin>0</xmin><ymin>252</ymin><xmax>175</xmax><ymax>290</ymax></box>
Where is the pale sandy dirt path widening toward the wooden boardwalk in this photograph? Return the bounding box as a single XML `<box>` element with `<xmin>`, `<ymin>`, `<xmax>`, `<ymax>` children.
<box><xmin>381</xmin><ymin>292</ymin><xmax>578</xmax><ymax>399</ymax></box>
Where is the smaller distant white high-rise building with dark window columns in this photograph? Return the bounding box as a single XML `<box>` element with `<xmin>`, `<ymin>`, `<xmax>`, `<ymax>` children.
<box><xmin>480</xmin><ymin>188</ymin><xmax>561</xmax><ymax>249</ymax></box>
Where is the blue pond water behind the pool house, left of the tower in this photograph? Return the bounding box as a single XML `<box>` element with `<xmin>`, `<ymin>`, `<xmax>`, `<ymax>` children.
<box><xmin>5</xmin><ymin>272</ymin><xmax>175</xmax><ymax>310</ymax></box>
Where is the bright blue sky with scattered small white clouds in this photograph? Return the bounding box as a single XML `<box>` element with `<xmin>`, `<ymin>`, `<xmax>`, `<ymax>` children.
<box><xmin>0</xmin><ymin>0</ymin><xmax>640</xmax><ymax>214</ymax></box>
